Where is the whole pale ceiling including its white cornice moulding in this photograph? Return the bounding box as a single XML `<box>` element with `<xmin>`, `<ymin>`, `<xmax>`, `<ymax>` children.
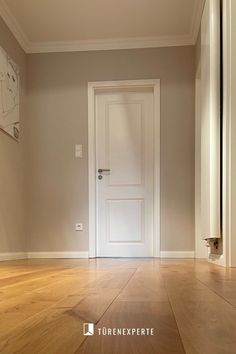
<box><xmin>0</xmin><ymin>0</ymin><xmax>204</xmax><ymax>53</ymax></box>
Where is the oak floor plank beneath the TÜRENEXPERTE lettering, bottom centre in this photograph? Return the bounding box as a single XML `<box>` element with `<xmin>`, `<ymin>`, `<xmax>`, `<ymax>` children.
<box><xmin>76</xmin><ymin>301</ymin><xmax>185</xmax><ymax>354</ymax></box>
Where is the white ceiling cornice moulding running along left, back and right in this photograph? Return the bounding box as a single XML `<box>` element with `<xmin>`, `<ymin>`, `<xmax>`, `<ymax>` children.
<box><xmin>0</xmin><ymin>0</ymin><xmax>205</xmax><ymax>54</ymax></box>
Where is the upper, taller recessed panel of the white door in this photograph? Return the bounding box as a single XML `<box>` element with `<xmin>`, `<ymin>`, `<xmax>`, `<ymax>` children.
<box><xmin>106</xmin><ymin>102</ymin><xmax>142</xmax><ymax>185</ymax></box>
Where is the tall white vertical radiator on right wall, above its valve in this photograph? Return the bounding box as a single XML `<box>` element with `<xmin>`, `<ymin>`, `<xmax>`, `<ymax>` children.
<box><xmin>201</xmin><ymin>0</ymin><xmax>221</xmax><ymax>240</ymax></box>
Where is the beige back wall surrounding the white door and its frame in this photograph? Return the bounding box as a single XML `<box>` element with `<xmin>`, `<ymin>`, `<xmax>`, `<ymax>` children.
<box><xmin>26</xmin><ymin>46</ymin><xmax>195</xmax><ymax>251</ymax></box>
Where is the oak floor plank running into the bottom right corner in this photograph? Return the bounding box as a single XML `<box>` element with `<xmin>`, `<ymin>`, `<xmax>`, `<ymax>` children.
<box><xmin>163</xmin><ymin>276</ymin><xmax>236</xmax><ymax>354</ymax></box>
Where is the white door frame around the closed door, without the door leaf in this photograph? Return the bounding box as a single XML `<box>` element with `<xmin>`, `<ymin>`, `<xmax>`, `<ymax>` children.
<box><xmin>88</xmin><ymin>79</ymin><xmax>161</xmax><ymax>258</ymax></box>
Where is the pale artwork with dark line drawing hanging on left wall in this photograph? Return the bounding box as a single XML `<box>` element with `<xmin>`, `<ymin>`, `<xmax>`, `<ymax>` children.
<box><xmin>0</xmin><ymin>47</ymin><xmax>20</xmax><ymax>141</ymax></box>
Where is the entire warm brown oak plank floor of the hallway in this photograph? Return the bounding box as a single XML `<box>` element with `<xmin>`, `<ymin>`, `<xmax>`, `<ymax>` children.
<box><xmin>0</xmin><ymin>259</ymin><xmax>236</xmax><ymax>354</ymax></box>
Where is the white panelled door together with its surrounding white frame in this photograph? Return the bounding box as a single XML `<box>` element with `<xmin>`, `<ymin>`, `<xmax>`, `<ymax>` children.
<box><xmin>89</xmin><ymin>80</ymin><xmax>160</xmax><ymax>257</ymax></box>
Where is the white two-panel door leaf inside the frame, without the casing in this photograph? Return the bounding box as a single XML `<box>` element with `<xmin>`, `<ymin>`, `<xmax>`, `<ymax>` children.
<box><xmin>95</xmin><ymin>89</ymin><xmax>154</xmax><ymax>257</ymax></box>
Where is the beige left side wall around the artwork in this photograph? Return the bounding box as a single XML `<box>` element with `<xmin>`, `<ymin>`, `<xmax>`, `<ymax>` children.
<box><xmin>0</xmin><ymin>17</ymin><xmax>26</xmax><ymax>253</ymax></box>
